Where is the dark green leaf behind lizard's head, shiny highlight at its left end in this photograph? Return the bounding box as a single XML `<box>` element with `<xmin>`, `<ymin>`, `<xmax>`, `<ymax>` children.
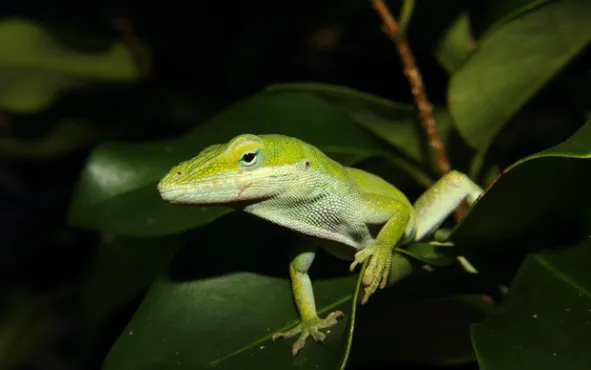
<box><xmin>69</xmin><ymin>93</ymin><xmax>382</xmax><ymax>237</ymax></box>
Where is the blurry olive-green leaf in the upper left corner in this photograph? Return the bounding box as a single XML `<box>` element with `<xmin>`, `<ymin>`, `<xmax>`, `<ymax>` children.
<box><xmin>0</xmin><ymin>19</ymin><xmax>139</xmax><ymax>113</ymax></box>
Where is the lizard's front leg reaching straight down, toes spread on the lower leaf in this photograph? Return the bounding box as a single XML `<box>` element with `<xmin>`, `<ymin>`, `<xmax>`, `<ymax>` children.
<box><xmin>272</xmin><ymin>246</ymin><xmax>345</xmax><ymax>356</ymax></box>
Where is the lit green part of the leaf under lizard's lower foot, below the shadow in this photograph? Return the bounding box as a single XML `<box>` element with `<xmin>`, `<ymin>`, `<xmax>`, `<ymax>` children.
<box><xmin>103</xmin><ymin>272</ymin><xmax>354</xmax><ymax>370</ymax></box>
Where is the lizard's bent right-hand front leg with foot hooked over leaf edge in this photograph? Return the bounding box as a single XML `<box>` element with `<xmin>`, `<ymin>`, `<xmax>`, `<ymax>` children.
<box><xmin>350</xmin><ymin>195</ymin><xmax>411</xmax><ymax>304</ymax></box>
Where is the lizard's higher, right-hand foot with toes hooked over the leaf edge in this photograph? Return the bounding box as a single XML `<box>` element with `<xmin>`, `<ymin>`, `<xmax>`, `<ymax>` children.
<box><xmin>349</xmin><ymin>244</ymin><xmax>392</xmax><ymax>304</ymax></box>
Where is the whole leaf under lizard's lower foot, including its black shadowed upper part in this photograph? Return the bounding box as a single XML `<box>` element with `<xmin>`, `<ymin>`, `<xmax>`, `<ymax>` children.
<box><xmin>103</xmin><ymin>213</ymin><xmax>356</xmax><ymax>370</ymax></box>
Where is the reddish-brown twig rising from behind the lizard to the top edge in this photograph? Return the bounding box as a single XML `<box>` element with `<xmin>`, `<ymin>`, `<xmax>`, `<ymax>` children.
<box><xmin>372</xmin><ymin>0</ymin><xmax>468</xmax><ymax>220</ymax></box>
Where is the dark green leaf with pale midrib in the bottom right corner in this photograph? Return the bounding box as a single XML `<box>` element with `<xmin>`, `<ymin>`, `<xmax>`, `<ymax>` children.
<box><xmin>471</xmin><ymin>240</ymin><xmax>591</xmax><ymax>370</ymax></box>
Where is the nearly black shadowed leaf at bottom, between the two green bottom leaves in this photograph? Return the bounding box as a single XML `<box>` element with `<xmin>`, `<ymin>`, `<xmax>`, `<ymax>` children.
<box><xmin>351</xmin><ymin>293</ymin><xmax>493</xmax><ymax>365</ymax></box>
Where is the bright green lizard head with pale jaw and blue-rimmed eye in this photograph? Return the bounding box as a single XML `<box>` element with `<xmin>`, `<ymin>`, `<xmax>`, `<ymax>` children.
<box><xmin>158</xmin><ymin>134</ymin><xmax>317</xmax><ymax>205</ymax></box>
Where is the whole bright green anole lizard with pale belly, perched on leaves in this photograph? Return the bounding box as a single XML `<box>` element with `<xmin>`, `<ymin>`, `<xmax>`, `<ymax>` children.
<box><xmin>158</xmin><ymin>134</ymin><xmax>483</xmax><ymax>356</ymax></box>
